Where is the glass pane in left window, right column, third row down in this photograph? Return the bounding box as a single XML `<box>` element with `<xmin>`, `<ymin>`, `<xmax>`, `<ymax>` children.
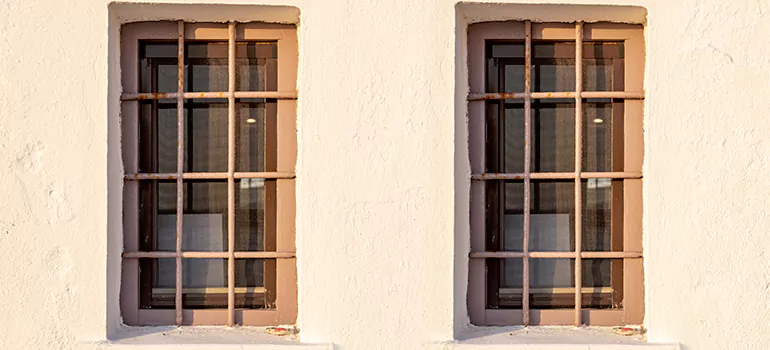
<box><xmin>235</xmin><ymin>179</ymin><xmax>276</xmax><ymax>251</ymax></box>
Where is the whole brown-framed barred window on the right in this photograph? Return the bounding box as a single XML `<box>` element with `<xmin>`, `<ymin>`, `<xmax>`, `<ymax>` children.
<box><xmin>468</xmin><ymin>21</ymin><xmax>644</xmax><ymax>326</ymax></box>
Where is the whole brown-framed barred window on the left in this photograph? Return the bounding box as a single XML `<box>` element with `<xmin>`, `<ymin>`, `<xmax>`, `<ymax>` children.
<box><xmin>121</xmin><ymin>21</ymin><xmax>297</xmax><ymax>325</ymax></box>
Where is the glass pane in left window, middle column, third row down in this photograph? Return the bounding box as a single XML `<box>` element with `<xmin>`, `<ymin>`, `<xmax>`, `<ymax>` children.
<box><xmin>181</xmin><ymin>180</ymin><xmax>227</xmax><ymax>252</ymax></box>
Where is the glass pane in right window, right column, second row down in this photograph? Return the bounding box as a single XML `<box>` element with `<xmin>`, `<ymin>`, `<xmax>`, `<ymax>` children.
<box><xmin>582</xmin><ymin>99</ymin><xmax>612</xmax><ymax>172</ymax></box>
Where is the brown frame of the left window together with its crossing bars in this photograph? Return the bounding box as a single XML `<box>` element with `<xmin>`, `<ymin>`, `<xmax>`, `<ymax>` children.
<box><xmin>120</xmin><ymin>21</ymin><xmax>298</xmax><ymax>326</ymax></box>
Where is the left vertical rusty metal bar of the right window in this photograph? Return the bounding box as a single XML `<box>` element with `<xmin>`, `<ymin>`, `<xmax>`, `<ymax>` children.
<box><xmin>521</xmin><ymin>21</ymin><xmax>532</xmax><ymax>326</ymax></box>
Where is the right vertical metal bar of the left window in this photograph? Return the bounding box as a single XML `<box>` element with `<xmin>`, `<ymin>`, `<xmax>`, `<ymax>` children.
<box><xmin>227</xmin><ymin>22</ymin><xmax>235</xmax><ymax>327</ymax></box>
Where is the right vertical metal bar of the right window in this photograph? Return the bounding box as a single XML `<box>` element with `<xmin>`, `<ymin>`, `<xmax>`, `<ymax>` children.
<box><xmin>575</xmin><ymin>22</ymin><xmax>583</xmax><ymax>326</ymax></box>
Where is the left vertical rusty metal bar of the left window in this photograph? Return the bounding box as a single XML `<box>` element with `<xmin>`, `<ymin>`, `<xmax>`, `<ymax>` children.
<box><xmin>174</xmin><ymin>21</ymin><xmax>185</xmax><ymax>326</ymax></box>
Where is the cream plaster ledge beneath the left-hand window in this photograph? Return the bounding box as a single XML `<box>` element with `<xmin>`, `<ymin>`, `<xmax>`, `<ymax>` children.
<box><xmin>79</xmin><ymin>326</ymin><xmax>333</xmax><ymax>350</ymax></box>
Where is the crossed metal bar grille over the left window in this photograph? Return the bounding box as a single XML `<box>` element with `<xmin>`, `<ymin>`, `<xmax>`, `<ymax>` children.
<box><xmin>121</xmin><ymin>21</ymin><xmax>297</xmax><ymax>326</ymax></box>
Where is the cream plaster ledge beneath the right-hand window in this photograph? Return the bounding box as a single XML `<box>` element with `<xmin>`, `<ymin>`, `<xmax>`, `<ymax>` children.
<box><xmin>432</xmin><ymin>326</ymin><xmax>680</xmax><ymax>350</ymax></box>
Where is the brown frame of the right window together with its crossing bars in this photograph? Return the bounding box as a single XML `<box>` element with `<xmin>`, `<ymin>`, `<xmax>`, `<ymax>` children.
<box><xmin>468</xmin><ymin>21</ymin><xmax>645</xmax><ymax>326</ymax></box>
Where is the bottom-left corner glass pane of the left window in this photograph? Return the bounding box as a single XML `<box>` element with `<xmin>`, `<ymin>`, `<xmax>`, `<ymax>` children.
<box><xmin>138</xmin><ymin>258</ymin><xmax>176</xmax><ymax>309</ymax></box>
